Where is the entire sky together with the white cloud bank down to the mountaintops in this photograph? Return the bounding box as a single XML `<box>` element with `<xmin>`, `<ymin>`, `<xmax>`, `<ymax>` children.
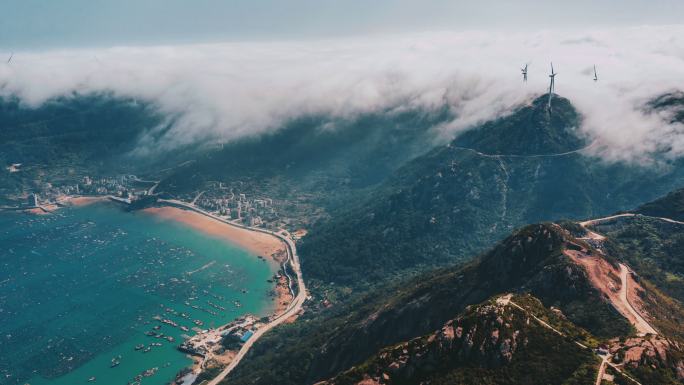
<box><xmin>0</xmin><ymin>0</ymin><xmax>684</xmax><ymax>163</ymax></box>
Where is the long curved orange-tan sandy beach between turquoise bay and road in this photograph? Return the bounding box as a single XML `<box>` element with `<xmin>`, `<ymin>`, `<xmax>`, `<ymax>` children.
<box><xmin>143</xmin><ymin>206</ymin><xmax>285</xmax><ymax>264</ymax></box>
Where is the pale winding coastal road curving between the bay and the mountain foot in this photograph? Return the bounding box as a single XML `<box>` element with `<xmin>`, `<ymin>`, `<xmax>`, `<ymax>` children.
<box><xmin>159</xmin><ymin>199</ymin><xmax>306</xmax><ymax>385</ymax></box>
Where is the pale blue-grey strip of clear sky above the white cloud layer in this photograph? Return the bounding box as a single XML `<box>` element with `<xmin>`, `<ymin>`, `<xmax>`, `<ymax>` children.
<box><xmin>0</xmin><ymin>0</ymin><xmax>684</xmax><ymax>51</ymax></box>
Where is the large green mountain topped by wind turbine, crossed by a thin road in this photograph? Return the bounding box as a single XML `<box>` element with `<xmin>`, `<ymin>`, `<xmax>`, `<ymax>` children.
<box><xmin>300</xmin><ymin>95</ymin><xmax>684</xmax><ymax>287</ymax></box>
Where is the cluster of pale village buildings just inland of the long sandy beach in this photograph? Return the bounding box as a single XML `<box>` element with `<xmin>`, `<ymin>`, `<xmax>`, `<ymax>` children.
<box><xmin>195</xmin><ymin>193</ymin><xmax>278</xmax><ymax>226</ymax></box>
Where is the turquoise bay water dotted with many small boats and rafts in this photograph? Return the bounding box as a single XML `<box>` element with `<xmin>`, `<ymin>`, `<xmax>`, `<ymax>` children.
<box><xmin>0</xmin><ymin>204</ymin><xmax>273</xmax><ymax>385</ymax></box>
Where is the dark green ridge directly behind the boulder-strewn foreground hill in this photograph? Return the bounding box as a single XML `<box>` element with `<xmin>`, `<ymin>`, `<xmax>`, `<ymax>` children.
<box><xmin>225</xmin><ymin>224</ymin><xmax>631</xmax><ymax>385</ymax></box>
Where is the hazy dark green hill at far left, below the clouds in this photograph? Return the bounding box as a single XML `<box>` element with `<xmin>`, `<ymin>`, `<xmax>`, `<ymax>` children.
<box><xmin>0</xmin><ymin>94</ymin><xmax>177</xmax><ymax>196</ymax></box>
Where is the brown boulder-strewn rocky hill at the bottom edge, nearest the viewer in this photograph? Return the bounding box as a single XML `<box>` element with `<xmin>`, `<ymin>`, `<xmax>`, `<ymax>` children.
<box><xmin>319</xmin><ymin>296</ymin><xmax>592</xmax><ymax>385</ymax></box>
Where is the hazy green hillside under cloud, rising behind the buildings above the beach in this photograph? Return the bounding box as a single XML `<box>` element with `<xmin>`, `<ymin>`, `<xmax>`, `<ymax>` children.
<box><xmin>159</xmin><ymin>109</ymin><xmax>450</xmax><ymax>200</ymax></box>
